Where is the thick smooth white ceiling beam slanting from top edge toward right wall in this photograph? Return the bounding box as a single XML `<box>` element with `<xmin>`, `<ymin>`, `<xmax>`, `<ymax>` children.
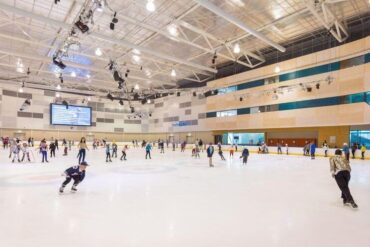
<box><xmin>194</xmin><ymin>0</ymin><xmax>286</xmax><ymax>52</ymax></box>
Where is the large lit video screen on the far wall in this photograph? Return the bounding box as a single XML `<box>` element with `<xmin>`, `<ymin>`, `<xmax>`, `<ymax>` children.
<box><xmin>50</xmin><ymin>104</ymin><xmax>92</xmax><ymax>126</ymax></box>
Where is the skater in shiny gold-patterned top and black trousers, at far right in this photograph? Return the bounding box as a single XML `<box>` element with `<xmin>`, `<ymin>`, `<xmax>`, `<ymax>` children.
<box><xmin>329</xmin><ymin>149</ymin><xmax>358</xmax><ymax>208</ymax></box>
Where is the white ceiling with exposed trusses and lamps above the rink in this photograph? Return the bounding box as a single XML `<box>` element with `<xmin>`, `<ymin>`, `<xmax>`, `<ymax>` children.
<box><xmin>0</xmin><ymin>0</ymin><xmax>370</xmax><ymax>98</ymax></box>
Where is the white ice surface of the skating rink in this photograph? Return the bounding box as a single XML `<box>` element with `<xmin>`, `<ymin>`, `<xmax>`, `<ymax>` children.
<box><xmin>0</xmin><ymin>148</ymin><xmax>370</xmax><ymax>247</ymax></box>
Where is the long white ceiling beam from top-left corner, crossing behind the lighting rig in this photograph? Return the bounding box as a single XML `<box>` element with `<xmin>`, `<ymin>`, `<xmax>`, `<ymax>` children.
<box><xmin>0</xmin><ymin>2</ymin><xmax>217</xmax><ymax>73</ymax></box>
